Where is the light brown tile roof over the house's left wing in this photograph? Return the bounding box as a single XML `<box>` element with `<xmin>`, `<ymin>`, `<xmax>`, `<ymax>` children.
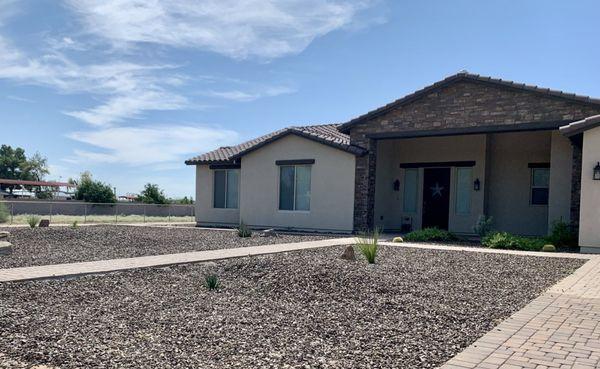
<box><xmin>185</xmin><ymin>124</ymin><xmax>366</xmax><ymax>165</ymax></box>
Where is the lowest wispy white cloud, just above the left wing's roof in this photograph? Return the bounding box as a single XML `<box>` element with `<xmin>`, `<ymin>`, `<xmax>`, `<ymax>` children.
<box><xmin>67</xmin><ymin>125</ymin><xmax>239</xmax><ymax>167</ymax></box>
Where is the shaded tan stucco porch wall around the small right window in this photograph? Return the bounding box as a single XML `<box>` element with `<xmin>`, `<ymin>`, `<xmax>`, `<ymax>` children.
<box><xmin>487</xmin><ymin>131</ymin><xmax>552</xmax><ymax>235</ymax></box>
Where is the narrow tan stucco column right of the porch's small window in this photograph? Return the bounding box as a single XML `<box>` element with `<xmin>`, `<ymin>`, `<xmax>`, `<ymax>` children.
<box><xmin>548</xmin><ymin>131</ymin><xmax>573</xmax><ymax>230</ymax></box>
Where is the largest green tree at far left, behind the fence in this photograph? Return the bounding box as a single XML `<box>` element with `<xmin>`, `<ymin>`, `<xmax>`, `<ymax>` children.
<box><xmin>0</xmin><ymin>145</ymin><xmax>50</xmax><ymax>193</ymax></box>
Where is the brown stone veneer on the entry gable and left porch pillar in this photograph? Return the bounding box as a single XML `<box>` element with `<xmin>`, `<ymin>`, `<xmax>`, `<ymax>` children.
<box><xmin>349</xmin><ymin>80</ymin><xmax>600</xmax><ymax>230</ymax></box>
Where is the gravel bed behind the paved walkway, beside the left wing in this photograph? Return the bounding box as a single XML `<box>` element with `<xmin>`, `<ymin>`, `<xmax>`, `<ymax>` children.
<box><xmin>0</xmin><ymin>225</ymin><xmax>326</xmax><ymax>268</ymax></box>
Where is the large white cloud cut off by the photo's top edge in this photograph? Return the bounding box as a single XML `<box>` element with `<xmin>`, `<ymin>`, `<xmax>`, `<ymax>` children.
<box><xmin>65</xmin><ymin>0</ymin><xmax>375</xmax><ymax>59</ymax></box>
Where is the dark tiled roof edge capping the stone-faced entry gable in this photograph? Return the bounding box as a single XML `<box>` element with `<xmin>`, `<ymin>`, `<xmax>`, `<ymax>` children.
<box><xmin>338</xmin><ymin>71</ymin><xmax>600</xmax><ymax>133</ymax></box>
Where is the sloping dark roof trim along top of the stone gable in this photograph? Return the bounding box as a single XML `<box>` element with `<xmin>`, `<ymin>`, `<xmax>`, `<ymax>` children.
<box><xmin>338</xmin><ymin>72</ymin><xmax>600</xmax><ymax>133</ymax></box>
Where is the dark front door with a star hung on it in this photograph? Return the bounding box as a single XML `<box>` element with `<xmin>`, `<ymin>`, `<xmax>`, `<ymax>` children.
<box><xmin>423</xmin><ymin>168</ymin><xmax>450</xmax><ymax>229</ymax></box>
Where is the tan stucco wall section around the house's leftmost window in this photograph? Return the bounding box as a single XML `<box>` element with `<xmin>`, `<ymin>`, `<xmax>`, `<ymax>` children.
<box><xmin>196</xmin><ymin>165</ymin><xmax>240</xmax><ymax>226</ymax></box>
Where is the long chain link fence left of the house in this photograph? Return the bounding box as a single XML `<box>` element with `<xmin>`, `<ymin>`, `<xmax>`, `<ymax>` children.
<box><xmin>0</xmin><ymin>200</ymin><xmax>195</xmax><ymax>224</ymax></box>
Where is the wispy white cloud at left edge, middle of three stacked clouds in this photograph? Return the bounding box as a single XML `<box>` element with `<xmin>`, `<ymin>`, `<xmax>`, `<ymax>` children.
<box><xmin>0</xmin><ymin>35</ymin><xmax>190</xmax><ymax>126</ymax></box>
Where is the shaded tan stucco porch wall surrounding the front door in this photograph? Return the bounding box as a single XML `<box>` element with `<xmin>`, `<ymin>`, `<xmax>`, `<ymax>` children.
<box><xmin>375</xmin><ymin>135</ymin><xmax>486</xmax><ymax>233</ymax></box>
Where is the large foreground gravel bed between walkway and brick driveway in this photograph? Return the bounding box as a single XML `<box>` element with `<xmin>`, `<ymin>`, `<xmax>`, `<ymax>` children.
<box><xmin>0</xmin><ymin>246</ymin><xmax>583</xmax><ymax>369</ymax></box>
